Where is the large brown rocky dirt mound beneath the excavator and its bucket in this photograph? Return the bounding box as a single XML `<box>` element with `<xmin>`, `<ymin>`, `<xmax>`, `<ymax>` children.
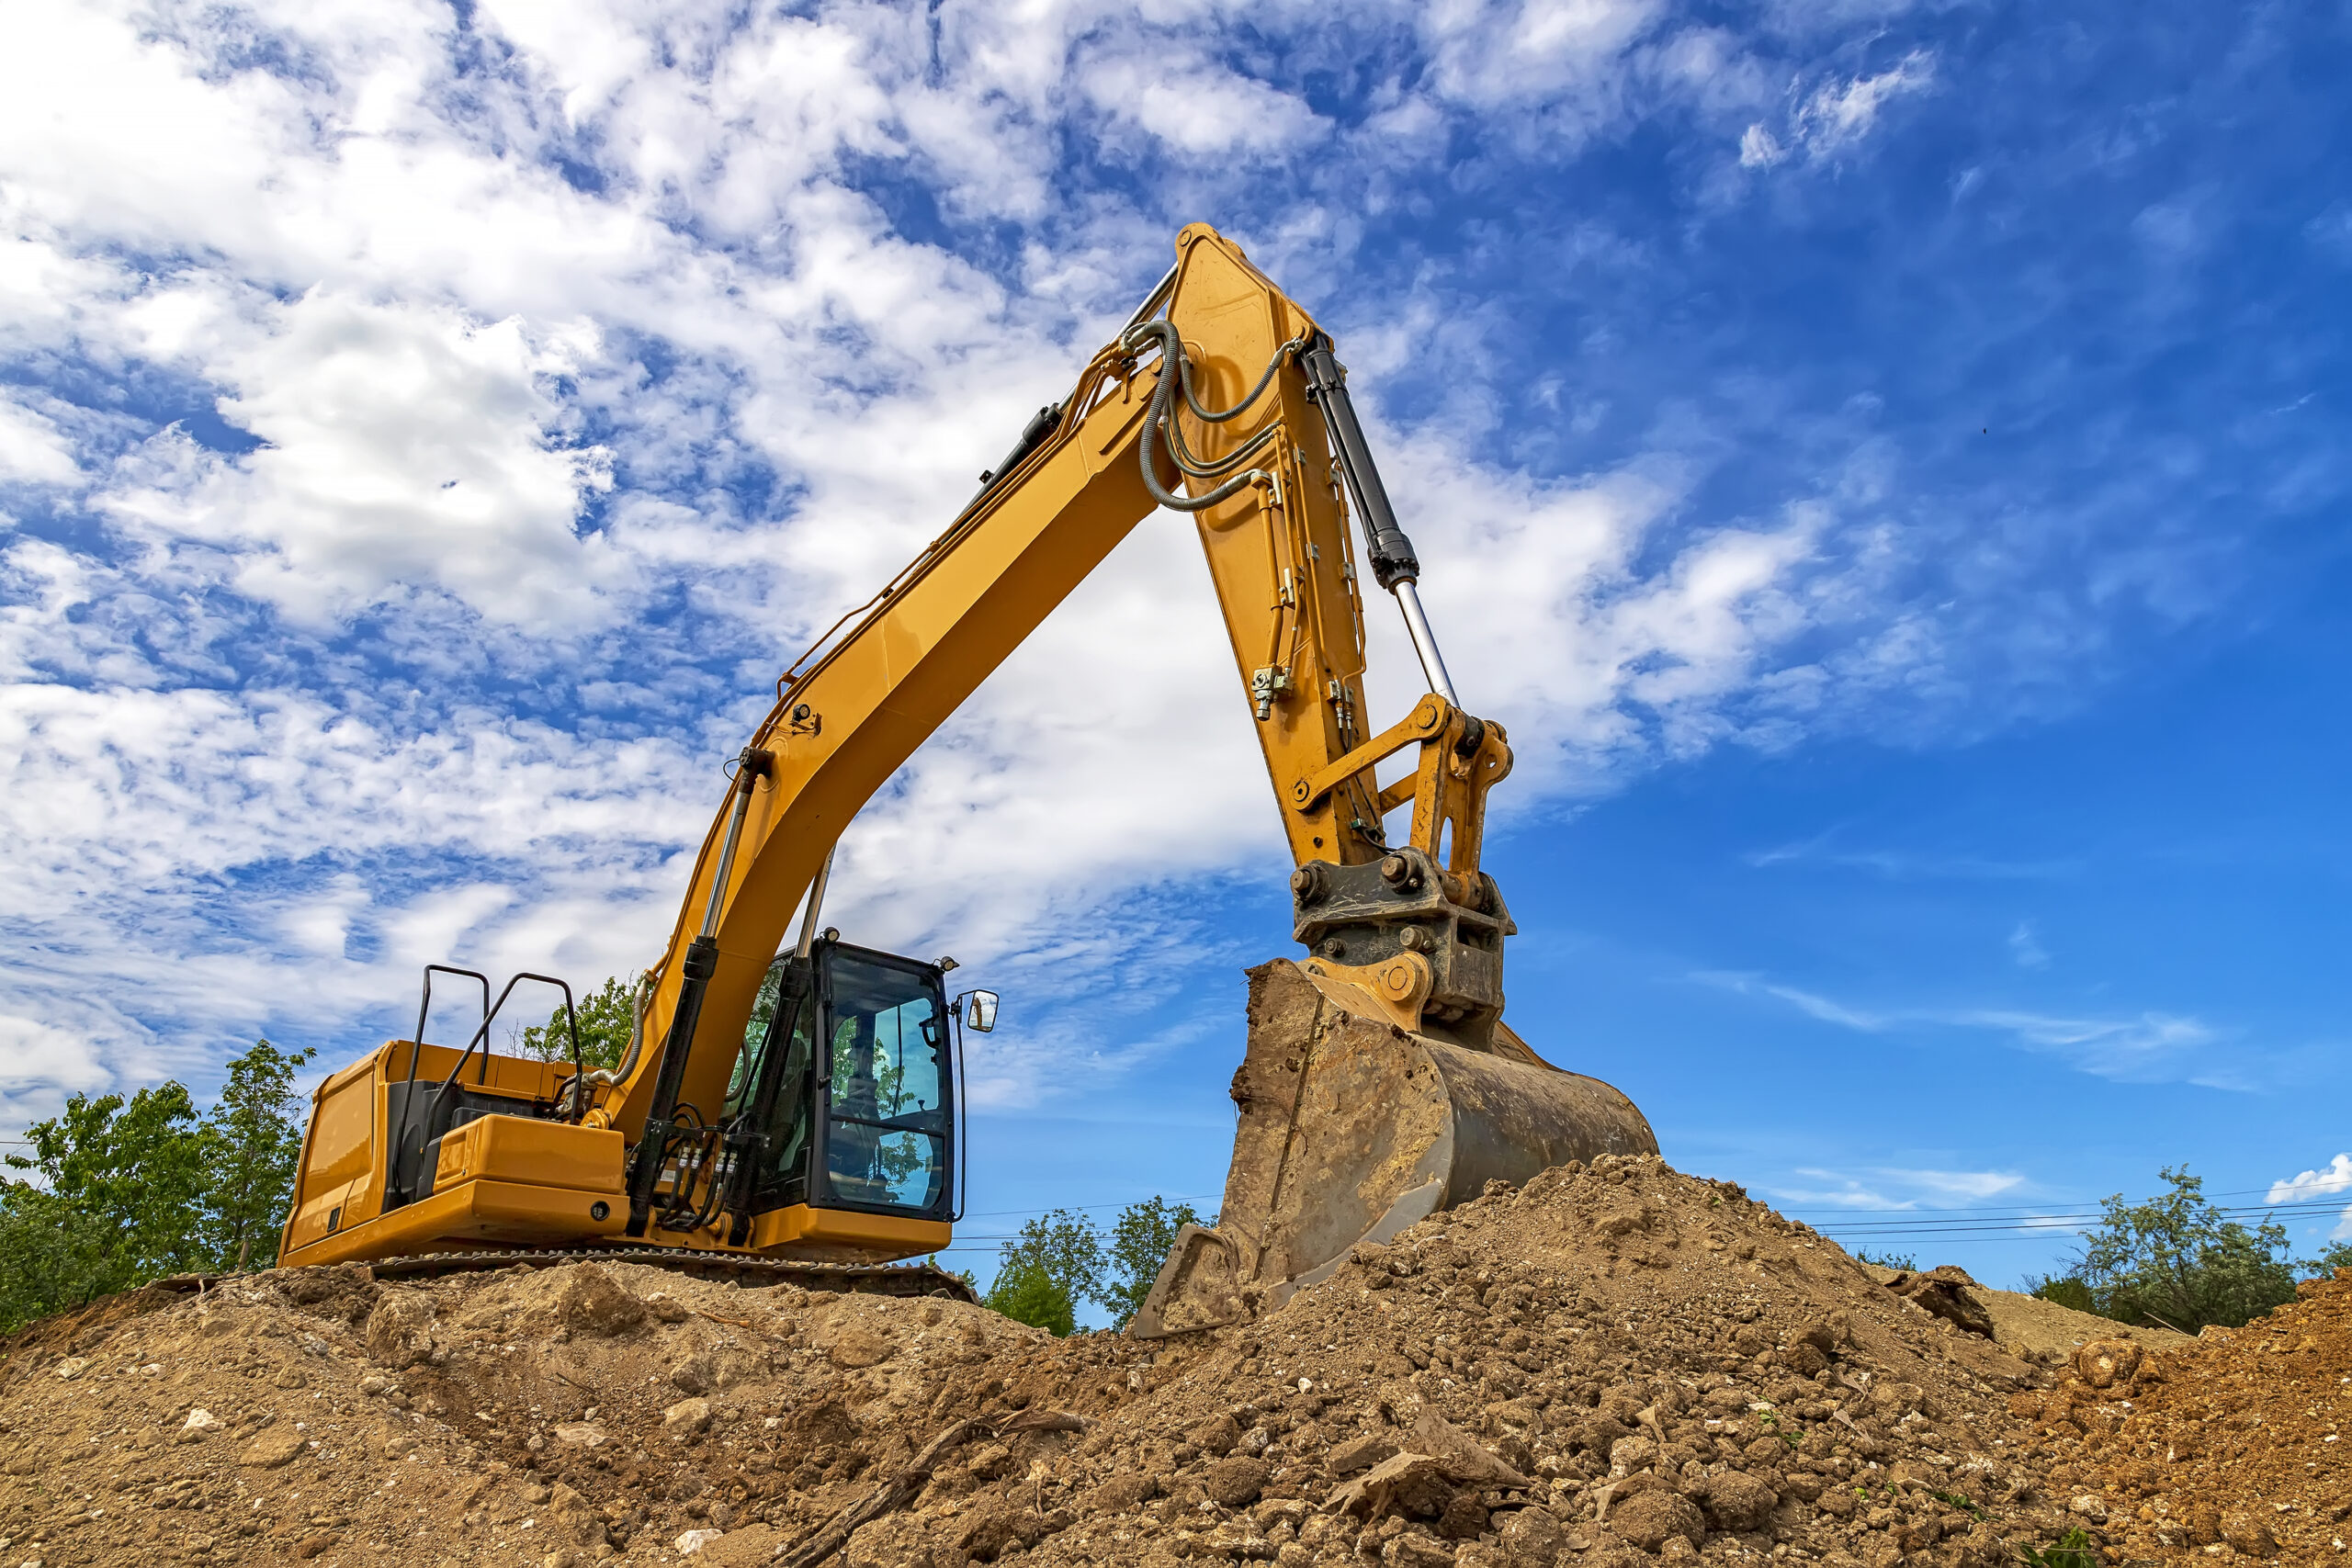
<box><xmin>0</xmin><ymin>1159</ymin><xmax>2126</xmax><ymax>1568</ymax></box>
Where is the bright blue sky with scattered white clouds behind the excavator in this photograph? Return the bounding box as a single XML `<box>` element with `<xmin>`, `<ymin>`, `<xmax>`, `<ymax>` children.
<box><xmin>0</xmin><ymin>0</ymin><xmax>2352</xmax><ymax>1283</ymax></box>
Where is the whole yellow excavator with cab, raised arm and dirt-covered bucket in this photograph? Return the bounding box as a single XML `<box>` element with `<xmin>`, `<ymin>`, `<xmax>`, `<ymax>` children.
<box><xmin>277</xmin><ymin>223</ymin><xmax>1656</xmax><ymax>1336</ymax></box>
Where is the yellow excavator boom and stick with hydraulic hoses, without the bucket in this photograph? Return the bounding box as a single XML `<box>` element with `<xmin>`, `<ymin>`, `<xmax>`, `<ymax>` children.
<box><xmin>591</xmin><ymin>223</ymin><xmax>1510</xmax><ymax>1175</ymax></box>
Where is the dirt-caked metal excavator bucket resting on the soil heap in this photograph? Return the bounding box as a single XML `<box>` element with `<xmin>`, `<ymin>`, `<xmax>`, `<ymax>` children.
<box><xmin>1129</xmin><ymin>959</ymin><xmax>1658</xmax><ymax>1340</ymax></box>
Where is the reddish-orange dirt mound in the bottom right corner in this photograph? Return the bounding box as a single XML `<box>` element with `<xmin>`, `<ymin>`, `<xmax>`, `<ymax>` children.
<box><xmin>2016</xmin><ymin>1269</ymin><xmax>2352</xmax><ymax>1563</ymax></box>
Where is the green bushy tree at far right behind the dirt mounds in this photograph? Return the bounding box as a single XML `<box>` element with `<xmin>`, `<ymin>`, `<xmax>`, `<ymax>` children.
<box><xmin>2075</xmin><ymin>1166</ymin><xmax>2296</xmax><ymax>1333</ymax></box>
